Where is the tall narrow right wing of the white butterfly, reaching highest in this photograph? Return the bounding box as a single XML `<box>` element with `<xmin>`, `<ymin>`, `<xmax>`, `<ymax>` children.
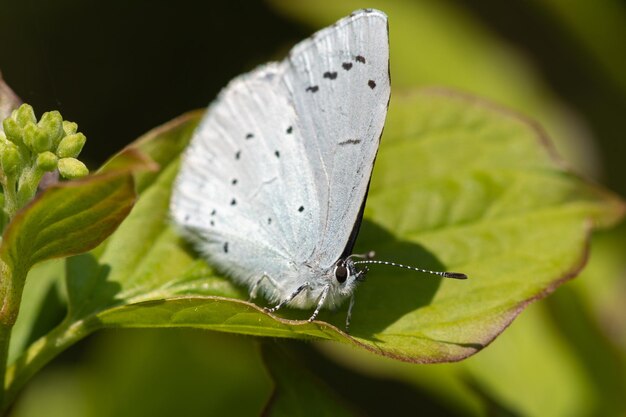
<box><xmin>285</xmin><ymin>9</ymin><xmax>391</xmax><ymax>268</ymax></box>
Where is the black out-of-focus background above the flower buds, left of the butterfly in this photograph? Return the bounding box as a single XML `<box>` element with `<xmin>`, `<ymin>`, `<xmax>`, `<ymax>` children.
<box><xmin>0</xmin><ymin>0</ymin><xmax>307</xmax><ymax>167</ymax></box>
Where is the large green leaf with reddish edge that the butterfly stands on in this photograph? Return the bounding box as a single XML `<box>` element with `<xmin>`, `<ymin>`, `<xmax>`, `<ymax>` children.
<box><xmin>6</xmin><ymin>91</ymin><xmax>623</xmax><ymax>404</ymax></box>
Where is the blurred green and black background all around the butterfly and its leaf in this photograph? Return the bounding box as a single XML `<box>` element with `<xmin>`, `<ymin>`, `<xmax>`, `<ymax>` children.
<box><xmin>0</xmin><ymin>0</ymin><xmax>626</xmax><ymax>417</ymax></box>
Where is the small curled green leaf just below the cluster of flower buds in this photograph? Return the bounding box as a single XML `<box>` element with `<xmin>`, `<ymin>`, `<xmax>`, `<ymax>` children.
<box><xmin>0</xmin><ymin>148</ymin><xmax>151</xmax><ymax>267</ymax></box>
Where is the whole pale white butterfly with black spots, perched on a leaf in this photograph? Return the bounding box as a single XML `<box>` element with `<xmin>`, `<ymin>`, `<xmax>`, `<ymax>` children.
<box><xmin>171</xmin><ymin>9</ymin><xmax>465</xmax><ymax>328</ymax></box>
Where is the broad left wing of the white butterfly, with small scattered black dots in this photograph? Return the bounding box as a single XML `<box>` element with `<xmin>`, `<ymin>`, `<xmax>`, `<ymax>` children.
<box><xmin>171</xmin><ymin>64</ymin><xmax>320</xmax><ymax>283</ymax></box>
